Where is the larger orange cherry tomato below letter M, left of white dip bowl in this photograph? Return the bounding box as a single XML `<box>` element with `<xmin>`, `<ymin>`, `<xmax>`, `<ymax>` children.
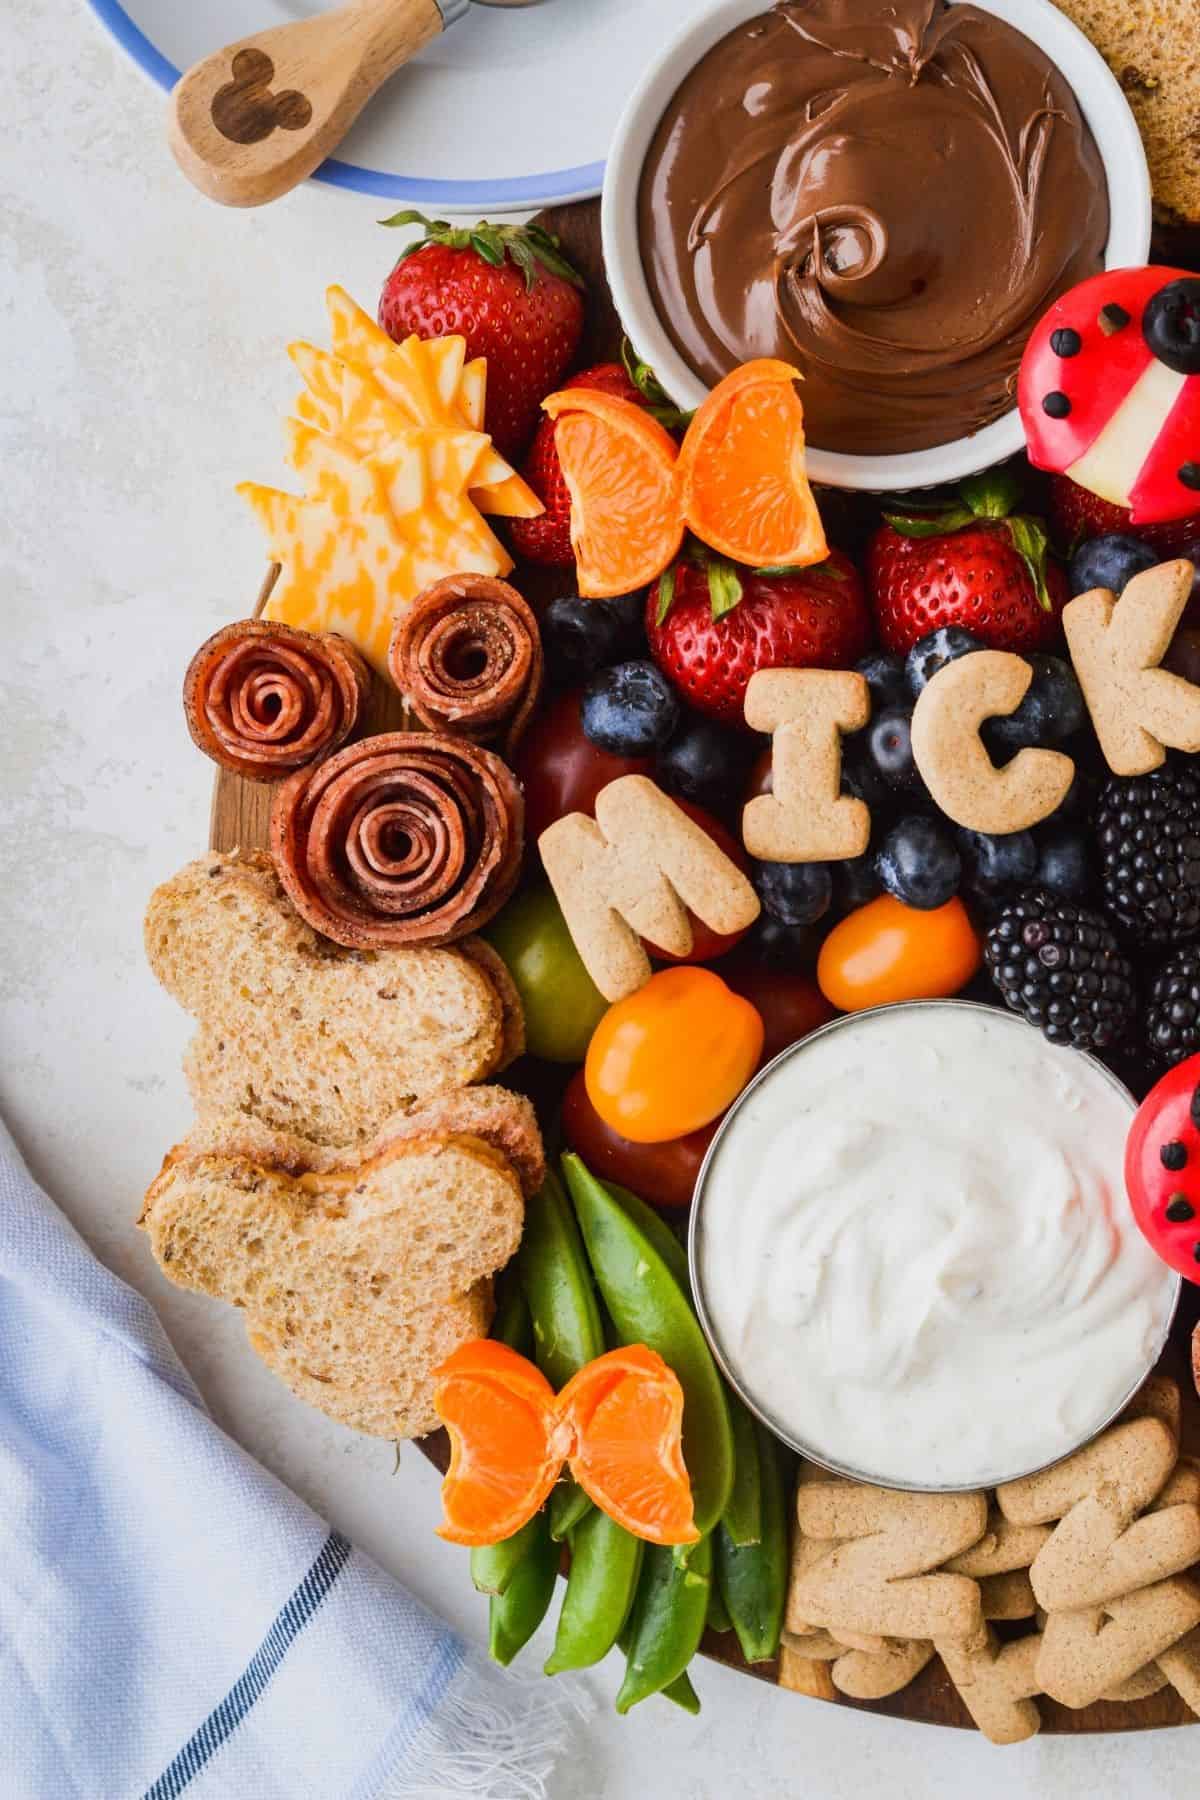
<box><xmin>583</xmin><ymin>967</ymin><xmax>763</xmax><ymax>1143</ymax></box>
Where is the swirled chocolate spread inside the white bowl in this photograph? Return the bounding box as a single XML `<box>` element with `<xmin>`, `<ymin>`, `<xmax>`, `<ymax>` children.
<box><xmin>639</xmin><ymin>0</ymin><xmax>1108</xmax><ymax>454</ymax></box>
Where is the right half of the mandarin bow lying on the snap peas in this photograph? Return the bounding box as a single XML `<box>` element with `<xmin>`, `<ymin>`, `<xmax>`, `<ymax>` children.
<box><xmin>558</xmin><ymin>1345</ymin><xmax>700</xmax><ymax>1544</ymax></box>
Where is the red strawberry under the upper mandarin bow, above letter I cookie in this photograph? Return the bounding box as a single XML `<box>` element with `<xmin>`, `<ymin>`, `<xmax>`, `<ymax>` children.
<box><xmin>646</xmin><ymin>551</ymin><xmax>871</xmax><ymax>725</ymax></box>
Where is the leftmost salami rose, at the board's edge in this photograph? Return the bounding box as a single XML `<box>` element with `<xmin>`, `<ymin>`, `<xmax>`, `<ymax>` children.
<box><xmin>184</xmin><ymin>619</ymin><xmax>371</xmax><ymax>781</ymax></box>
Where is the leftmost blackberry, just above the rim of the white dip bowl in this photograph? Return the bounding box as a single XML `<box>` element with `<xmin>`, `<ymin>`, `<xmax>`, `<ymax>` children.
<box><xmin>984</xmin><ymin>889</ymin><xmax>1133</xmax><ymax>1049</ymax></box>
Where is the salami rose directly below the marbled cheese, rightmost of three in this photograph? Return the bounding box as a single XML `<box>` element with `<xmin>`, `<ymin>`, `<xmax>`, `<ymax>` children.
<box><xmin>387</xmin><ymin>574</ymin><xmax>542</xmax><ymax>754</ymax></box>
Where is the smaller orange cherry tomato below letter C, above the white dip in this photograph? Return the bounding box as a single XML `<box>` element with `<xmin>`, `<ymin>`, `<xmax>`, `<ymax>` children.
<box><xmin>817</xmin><ymin>895</ymin><xmax>982</xmax><ymax>1012</ymax></box>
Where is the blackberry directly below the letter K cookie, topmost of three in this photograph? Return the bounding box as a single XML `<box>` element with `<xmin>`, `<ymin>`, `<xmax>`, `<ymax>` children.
<box><xmin>1096</xmin><ymin>758</ymin><xmax>1200</xmax><ymax>945</ymax></box>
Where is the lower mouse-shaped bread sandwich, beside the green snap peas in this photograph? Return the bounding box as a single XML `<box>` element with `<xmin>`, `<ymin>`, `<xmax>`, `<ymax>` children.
<box><xmin>140</xmin><ymin>1089</ymin><xmax>543</xmax><ymax>1436</ymax></box>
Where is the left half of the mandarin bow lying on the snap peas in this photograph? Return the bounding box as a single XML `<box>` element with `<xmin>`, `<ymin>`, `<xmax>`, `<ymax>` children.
<box><xmin>434</xmin><ymin>1337</ymin><xmax>570</xmax><ymax>1546</ymax></box>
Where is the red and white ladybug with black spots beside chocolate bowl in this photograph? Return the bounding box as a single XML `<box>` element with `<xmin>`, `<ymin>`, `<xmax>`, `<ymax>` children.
<box><xmin>1016</xmin><ymin>268</ymin><xmax>1200</xmax><ymax>526</ymax></box>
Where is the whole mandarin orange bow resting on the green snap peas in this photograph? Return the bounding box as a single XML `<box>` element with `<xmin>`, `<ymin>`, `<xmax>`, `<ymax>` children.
<box><xmin>434</xmin><ymin>1337</ymin><xmax>698</xmax><ymax>1544</ymax></box>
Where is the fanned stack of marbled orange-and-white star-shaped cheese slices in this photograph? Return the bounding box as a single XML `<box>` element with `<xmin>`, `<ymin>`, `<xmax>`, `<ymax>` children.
<box><xmin>237</xmin><ymin>288</ymin><xmax>542</xmax><ymax>675</ymax></box>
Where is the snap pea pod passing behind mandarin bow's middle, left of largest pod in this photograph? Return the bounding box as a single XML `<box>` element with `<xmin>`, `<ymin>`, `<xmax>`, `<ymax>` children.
<box><xmin>516</xmin><ymin>1170</ymin><xmax>604</xmax><ymax>1543</ymax></box>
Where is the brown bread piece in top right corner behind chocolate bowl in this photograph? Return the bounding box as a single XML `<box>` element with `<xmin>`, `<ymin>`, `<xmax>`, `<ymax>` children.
<box><xmin>1056</xmin><ymin>0</ymin><xmax>1200</xmax><ymax>225</ymax></box>
